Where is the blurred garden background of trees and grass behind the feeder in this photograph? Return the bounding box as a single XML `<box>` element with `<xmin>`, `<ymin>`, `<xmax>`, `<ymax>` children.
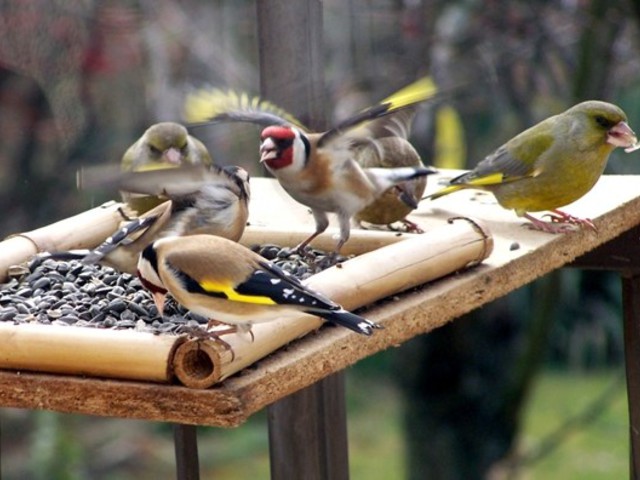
<box><xmin>0</xmin><ymin>0</ymin><xmax>640</xmax><ymax>480</ymax></box>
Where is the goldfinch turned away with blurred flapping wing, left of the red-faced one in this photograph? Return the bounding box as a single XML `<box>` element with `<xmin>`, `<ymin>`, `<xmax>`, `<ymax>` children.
<box><xmin>48</xmin><ymin>165</ymin><xmax>249</xmax><ymax>274</ymax></box>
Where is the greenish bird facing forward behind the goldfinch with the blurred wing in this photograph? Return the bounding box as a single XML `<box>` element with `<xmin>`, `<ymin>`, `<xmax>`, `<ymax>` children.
<box><xmin>120</xmin><ymin>122</ymin><xmax>213</xmax><ymax>214</ymax></box>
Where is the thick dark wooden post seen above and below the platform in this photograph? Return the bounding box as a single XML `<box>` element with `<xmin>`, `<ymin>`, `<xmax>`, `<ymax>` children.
<box><xmin>257</xmin><ymin>0</ymin><xmax>349</xmax><ymax>480</ymax></box>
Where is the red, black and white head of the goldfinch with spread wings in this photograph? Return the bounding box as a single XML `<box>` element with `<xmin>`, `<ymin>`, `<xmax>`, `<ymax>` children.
<box><xmin>260</xmin><ymin>125</ymin><xmax>310</xmax><ymax>170</ymax></box>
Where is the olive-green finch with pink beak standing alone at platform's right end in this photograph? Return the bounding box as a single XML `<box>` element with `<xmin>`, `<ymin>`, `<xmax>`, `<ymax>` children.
<box><xmin>425</xmin><ymin>100</ymin><xmax>637</xmax><ymax>233</ymax></box>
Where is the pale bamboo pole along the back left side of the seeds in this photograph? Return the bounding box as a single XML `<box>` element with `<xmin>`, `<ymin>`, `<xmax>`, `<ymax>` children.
<box><xmin>0</xmin><ymin>202</ymin><xmax>129</xmax><ymax>283</ymax></box>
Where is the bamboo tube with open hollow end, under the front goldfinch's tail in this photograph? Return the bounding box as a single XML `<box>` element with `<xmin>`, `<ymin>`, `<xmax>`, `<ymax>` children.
<box><xmin>174</xmin><ymin>218</ymin><xmax>493</xmax><ymax>388</ymax></box>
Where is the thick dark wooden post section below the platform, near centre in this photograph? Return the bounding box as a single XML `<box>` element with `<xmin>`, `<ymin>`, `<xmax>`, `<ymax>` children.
<box><xmin>268</xmin><ymin>372</ymin><xmax>349</xmax><ymax>480</ymax></box>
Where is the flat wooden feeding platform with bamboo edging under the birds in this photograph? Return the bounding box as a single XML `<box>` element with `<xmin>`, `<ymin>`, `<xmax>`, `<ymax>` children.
<box><xmin>0</xmin><ymin>170</ymin><xmax>640</xmax><ymax>476</ymax></box>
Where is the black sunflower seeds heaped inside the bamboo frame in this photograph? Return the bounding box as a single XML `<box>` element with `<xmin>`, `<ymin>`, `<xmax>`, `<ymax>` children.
<box><xmin>0</xmin><ymin>245</ymin><xmax>345</xmax><ymax>334</ymax></box>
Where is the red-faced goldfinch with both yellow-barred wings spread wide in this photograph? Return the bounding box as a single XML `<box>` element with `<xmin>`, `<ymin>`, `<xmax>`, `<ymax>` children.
<box><xmin>186</xmin><ymin>79</ymin><xmax>436</xmax><ymax>253</ymax></box>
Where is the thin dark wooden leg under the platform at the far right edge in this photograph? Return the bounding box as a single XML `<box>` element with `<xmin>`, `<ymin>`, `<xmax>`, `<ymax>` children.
<box><xmin>622</xmin><ymin>275</ymin><xmax>640</xmax><ymax>480</ymax></box>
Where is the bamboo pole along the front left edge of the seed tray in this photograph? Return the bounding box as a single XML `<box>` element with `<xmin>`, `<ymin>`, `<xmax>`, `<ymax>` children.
<box><xmin>0</xmin><ymin>322</ymin><xmax>185</xmax><ymax>383</ymax></box>
